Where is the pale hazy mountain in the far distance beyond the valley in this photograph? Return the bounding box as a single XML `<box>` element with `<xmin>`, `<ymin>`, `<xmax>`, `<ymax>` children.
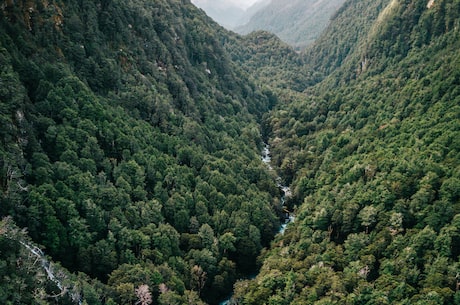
<box><xmin>236</xmin><ymin>0</ymin><xmax>344</xmax><ymax>49</ymax></box>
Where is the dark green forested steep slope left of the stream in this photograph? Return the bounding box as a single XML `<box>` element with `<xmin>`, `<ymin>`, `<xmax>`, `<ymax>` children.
<box><xmin>0</xmin><ymin>0</ymin><xmax>279</xmax><ymax>304</ymax></box>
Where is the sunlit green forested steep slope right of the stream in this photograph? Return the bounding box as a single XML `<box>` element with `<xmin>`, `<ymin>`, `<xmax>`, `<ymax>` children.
<box><xmin>234</xmin><ymin>0</ymin><xmax>460</xmax><ymax>304</ymax></box>
